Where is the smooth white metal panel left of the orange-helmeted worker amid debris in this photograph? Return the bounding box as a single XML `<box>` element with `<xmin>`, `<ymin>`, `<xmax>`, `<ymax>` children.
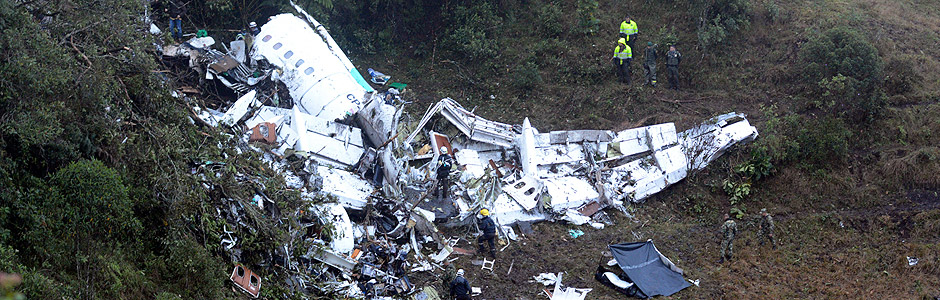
<box><xmin>317</xmin><ymin>166</ymin><xmax>375</xmax><ymax>210</ymax></box>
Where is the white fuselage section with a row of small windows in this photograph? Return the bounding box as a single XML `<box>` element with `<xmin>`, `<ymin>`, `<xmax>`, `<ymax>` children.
<box><xmin>252</xmin><ymin>14</ymin><xmax>368</xmax><ymax>120</ymax></box>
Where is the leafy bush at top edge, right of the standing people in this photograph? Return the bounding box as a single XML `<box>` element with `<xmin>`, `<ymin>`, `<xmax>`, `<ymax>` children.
<box><xmin>694</xmin><ymin>0</ymin><xmax>751</xmax><ymax>48</ymax></box>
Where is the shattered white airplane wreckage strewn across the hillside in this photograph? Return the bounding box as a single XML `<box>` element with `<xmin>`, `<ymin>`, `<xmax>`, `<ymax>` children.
<box><xmin>161</xmin><ymin>5</ymin><xmax>757</xmax><ymax>299</ymax></box>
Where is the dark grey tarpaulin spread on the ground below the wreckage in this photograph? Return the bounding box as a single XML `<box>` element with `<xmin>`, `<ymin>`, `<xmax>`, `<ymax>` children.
<box><xmin>608</xmin><ymin>241</ymin><xmax>691</xmax><ymax>297</ymax></box>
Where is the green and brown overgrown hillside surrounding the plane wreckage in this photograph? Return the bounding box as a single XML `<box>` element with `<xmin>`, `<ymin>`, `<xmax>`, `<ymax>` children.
<box><xmin>0</xmin><ymin>0</ymin><xmax>940</xmax><ymax>299</ymax></box>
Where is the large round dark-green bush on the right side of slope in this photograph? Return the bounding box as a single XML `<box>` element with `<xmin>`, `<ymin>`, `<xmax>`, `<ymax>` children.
<box><xmin>800</xmin><ymin>27</ymin><xmax>885</xmax><ymax>122</ymax></box>
